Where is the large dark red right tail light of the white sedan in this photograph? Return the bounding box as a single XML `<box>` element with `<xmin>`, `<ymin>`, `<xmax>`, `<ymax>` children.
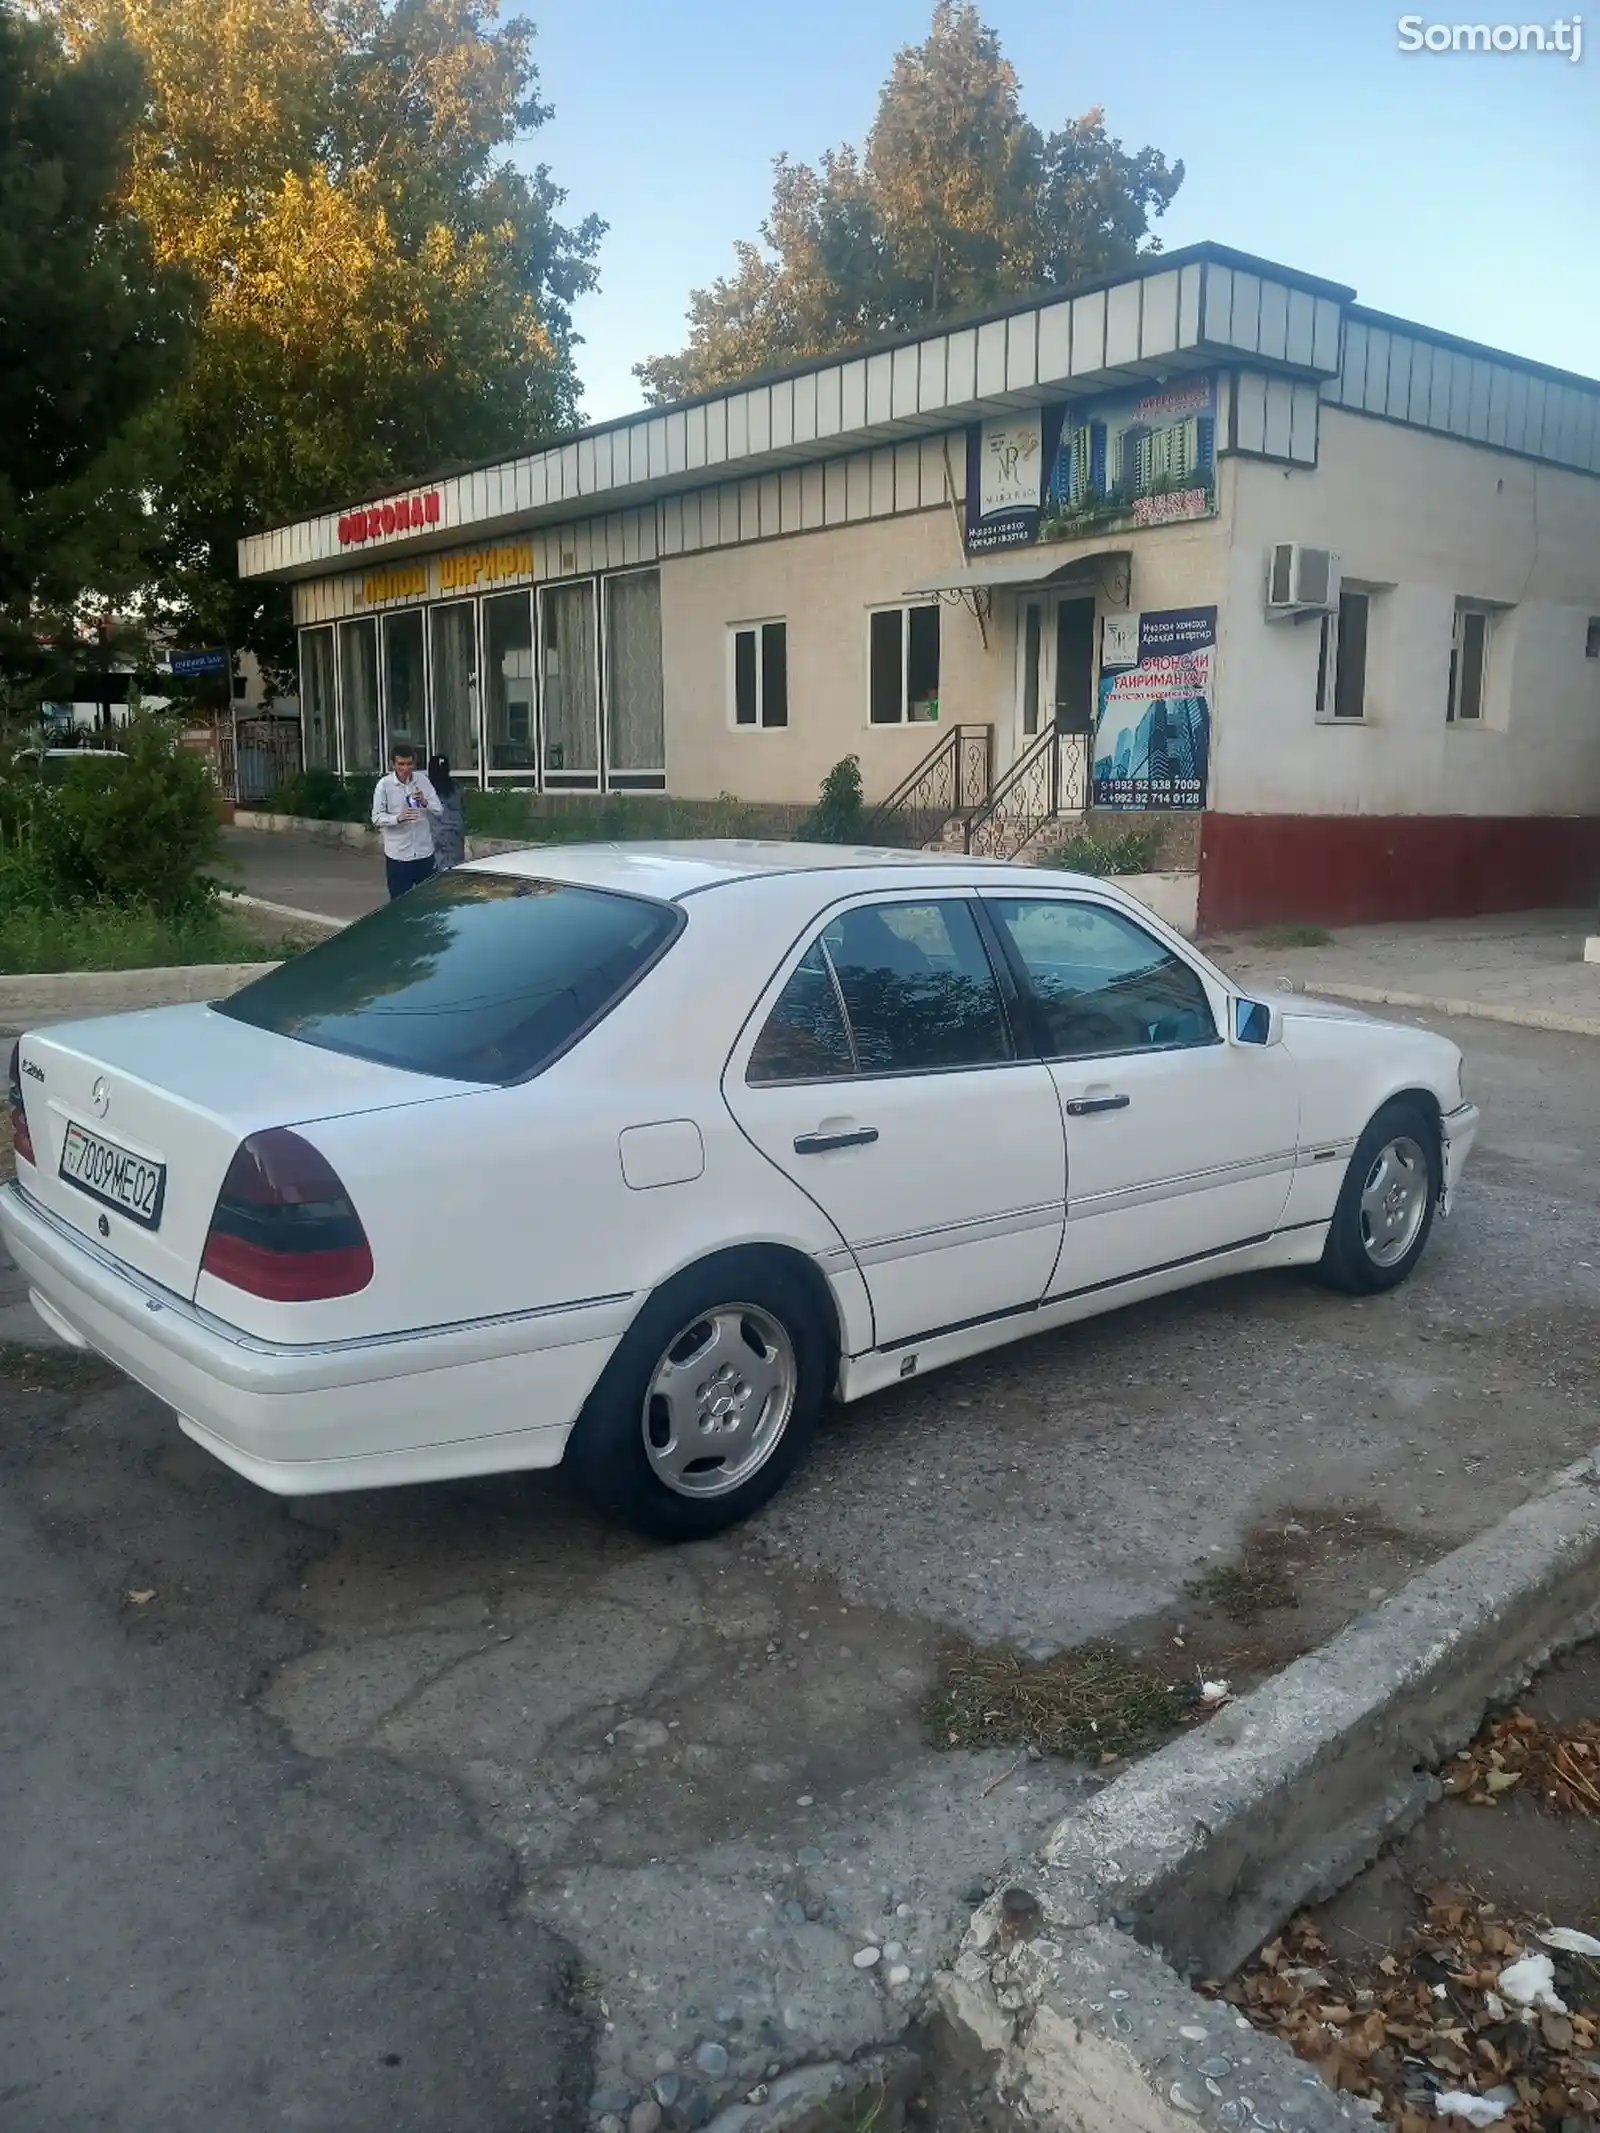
<box><xmin>201</xmin><ymin>1126</ymin><xmax>371</xmax><ymax>1303</ymax></box>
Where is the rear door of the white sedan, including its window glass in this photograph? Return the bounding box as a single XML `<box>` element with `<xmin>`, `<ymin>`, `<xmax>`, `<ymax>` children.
<box><xmin>723</xmin><ymin>896</ymin><xmax>1067</xmax><ymax>1348</ymax></box>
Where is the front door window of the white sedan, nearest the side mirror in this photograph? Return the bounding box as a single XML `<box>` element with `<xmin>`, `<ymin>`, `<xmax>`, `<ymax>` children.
<box><xmin>988</xmin><ymin>896</ymin><xmax>1216</xmax><ymax>1058</ymax></box>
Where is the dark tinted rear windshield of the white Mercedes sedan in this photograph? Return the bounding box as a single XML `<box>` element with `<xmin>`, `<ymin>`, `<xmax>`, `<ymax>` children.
<box><xmin>220</xmin><ymin>872</ymin><xmax>683</xmax><ymax>1084</ymax></box>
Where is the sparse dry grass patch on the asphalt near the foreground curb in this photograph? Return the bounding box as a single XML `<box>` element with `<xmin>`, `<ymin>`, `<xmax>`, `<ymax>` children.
<box><xmin>928</xmin><ymin>1645</ymin><xmax>1199</xmax><ymax>1762</ymax></box>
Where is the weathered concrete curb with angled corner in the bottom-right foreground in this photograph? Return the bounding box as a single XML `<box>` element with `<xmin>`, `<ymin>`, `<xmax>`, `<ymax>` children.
<box><xmin>937</xmin><ymin>1455</ymin><xmax>1600</xmax><ymax>2133</ymax></box>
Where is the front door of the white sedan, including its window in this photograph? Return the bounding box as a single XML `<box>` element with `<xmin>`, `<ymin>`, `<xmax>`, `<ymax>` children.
<box><xmin>983</xmin><ymin>894</ymin><xmax>1299</xmax><ymax>1297</ymax></box>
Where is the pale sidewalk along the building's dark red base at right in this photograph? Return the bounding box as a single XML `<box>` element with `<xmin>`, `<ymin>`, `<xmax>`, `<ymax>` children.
<box><xmin>1203</xmin><ymin>911</ymin><xmax>1600</xmax><ymax>1037</ymax></box>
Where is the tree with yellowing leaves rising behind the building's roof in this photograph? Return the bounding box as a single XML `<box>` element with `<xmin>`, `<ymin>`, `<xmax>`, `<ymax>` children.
<box><xmin>634</xmin><ymin>0</ymin><xmax>1184</xmax><ymax>401</ymax></box>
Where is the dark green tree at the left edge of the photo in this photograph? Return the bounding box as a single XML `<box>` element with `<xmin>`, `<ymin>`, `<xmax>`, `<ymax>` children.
<box><xmin>0</xmin><ymin>0</ymin><xmax>192</xmax><ymax>693</ymax></box>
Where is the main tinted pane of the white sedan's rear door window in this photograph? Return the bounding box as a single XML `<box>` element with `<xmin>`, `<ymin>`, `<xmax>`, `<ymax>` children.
<box><xmin>821</xmin><ymin>902</ymin><xmax>1011</xmax><ymax>1073</ymax></box>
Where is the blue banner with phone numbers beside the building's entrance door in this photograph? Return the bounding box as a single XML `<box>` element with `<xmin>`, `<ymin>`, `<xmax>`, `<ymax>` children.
<box><xmin>1092</xmin><ymin>608</ymin><xmax>1216</xmax><ymax>811</ymax></box>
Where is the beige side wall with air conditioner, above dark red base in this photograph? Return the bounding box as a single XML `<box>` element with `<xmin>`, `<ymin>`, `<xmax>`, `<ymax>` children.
<box><xmin>1210</xmin><ymin>407</ymin><xmax>1600</xmax><ymax>815</ymax></box>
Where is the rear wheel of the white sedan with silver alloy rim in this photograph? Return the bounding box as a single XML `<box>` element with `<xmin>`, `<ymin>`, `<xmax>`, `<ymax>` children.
<box><xmin>563</xmin><ymin>1250</ymin><xmax>836</xmax><ymax>1540</ymax></box>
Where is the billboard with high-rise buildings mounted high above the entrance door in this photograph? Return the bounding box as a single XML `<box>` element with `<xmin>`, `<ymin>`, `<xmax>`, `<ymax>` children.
<box><xmin>966</xmin><ymin>375</ymin><xmax>1216</xmax><ymax>555</ymax></box>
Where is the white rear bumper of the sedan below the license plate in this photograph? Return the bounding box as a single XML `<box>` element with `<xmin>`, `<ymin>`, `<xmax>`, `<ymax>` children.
<box><xmin>0</xmin><ymin>1184</ymin><xmax>636</xmax><ymax>1495</ymax></box>
